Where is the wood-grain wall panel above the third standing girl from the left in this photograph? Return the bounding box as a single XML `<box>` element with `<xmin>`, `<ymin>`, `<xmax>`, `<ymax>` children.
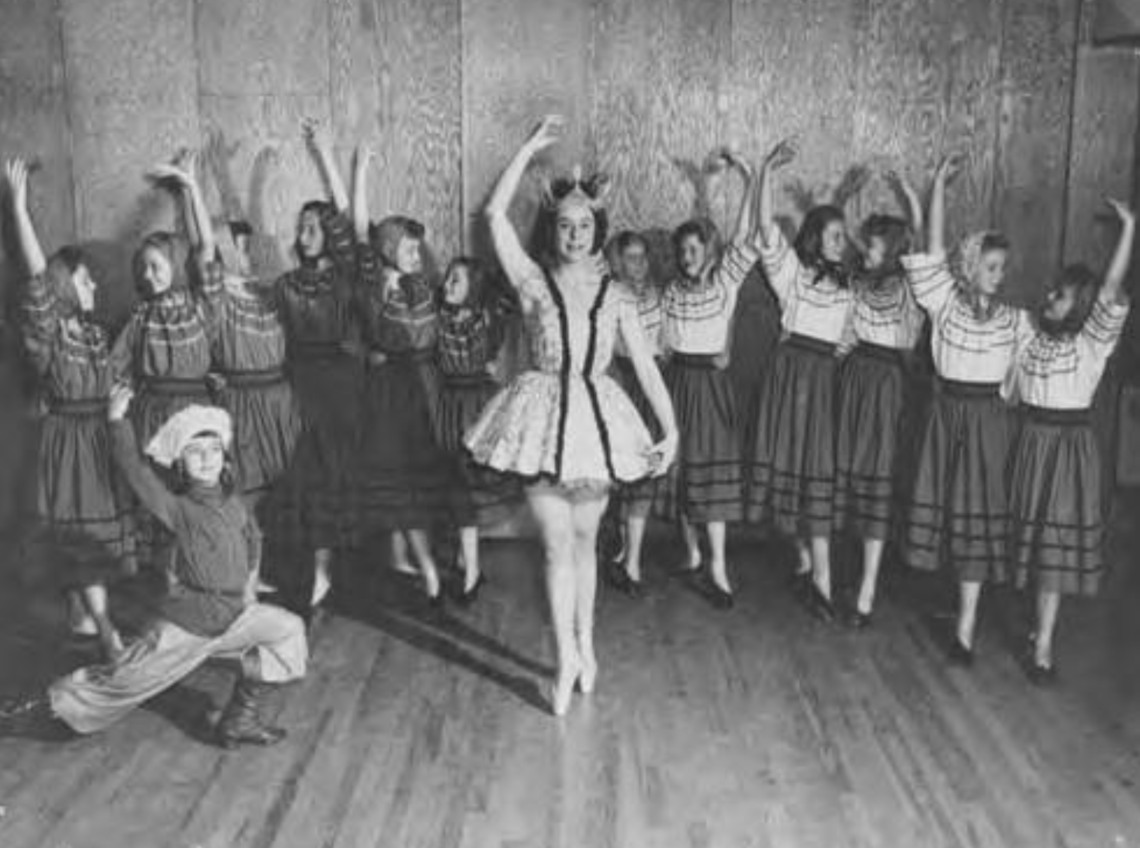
<box><xmin>195</xmin><ymin>0</ymin><xmax>330</xmax><ymax>276</ymax></box>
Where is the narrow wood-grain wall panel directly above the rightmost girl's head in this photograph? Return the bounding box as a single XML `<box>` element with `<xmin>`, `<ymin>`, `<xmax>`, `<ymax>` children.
<box><xmin>994</xmin><ymin>0</ymin><xmax>1078</xmax><ymax>301</ymax></box>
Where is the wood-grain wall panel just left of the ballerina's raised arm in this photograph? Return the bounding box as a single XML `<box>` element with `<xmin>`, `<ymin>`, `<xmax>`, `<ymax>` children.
<box><xmin>329</xmin><ymin>0</ymin><xmax>463</xmax><ymax>261</ymax></box>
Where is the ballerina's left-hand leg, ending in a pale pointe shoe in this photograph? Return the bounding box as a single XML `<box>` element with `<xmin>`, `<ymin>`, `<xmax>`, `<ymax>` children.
<box><xmin>527</xmin><ymin>491</ymin><xmax>581</xmax><ymax>716</ymax></box>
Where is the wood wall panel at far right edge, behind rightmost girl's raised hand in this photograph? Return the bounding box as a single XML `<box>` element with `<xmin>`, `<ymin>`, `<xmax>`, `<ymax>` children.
<box><xmin>1065</xmin><ymin>44</ymin><xmax>1140</xmax><ymax>268</ymax></box>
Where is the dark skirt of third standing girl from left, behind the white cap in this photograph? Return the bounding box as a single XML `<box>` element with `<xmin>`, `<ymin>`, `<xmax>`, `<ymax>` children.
<box><xmin>218</xmin><ymin>370</ymin><xmax>301</xmax><ymax>495</ymax></box>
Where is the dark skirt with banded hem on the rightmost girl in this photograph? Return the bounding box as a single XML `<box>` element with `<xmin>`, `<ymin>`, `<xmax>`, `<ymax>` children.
<box><xmin>1010</xmin><ymin>408</ymin><xmax>1105</xmax><ymax>595</ymax></box>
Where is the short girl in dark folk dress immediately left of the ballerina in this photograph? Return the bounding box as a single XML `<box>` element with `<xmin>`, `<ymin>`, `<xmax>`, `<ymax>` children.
<box><xmin>434</xmin><ymin>258</ymin><xmax>522</xmax><ymax>605</ymax></box>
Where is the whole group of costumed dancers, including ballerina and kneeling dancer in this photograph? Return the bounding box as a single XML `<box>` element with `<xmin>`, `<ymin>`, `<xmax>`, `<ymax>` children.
<box><xmin>0</xmin><ymin>115</ymin><xmax>1135</xmax><ymax>734</ymax></box>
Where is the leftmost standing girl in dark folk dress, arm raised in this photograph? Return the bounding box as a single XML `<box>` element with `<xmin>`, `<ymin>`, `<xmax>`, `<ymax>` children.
<box><xmin>7</xmin><ymin>160</ymin><xmax>133</xmax><ymax>659</ymax></box>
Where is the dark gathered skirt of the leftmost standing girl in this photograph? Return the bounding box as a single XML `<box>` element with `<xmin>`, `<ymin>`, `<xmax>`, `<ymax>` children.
<box><xmin>29</xmin><ymin>400</ymin><xmax>135</xmax><ymax>588</ymax></box>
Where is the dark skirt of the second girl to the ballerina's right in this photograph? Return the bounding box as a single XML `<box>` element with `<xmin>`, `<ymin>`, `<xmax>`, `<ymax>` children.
<box><xmin>653</xmin><ymin>353</ymin><xmax>743</xmax><ymax>523</ymax></box>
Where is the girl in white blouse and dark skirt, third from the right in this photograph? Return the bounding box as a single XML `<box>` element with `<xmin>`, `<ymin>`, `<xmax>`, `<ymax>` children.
<box><xmin>836</xmin><ymin>187</ymin><xmax>925</xmax><ymax>627</ymax></box>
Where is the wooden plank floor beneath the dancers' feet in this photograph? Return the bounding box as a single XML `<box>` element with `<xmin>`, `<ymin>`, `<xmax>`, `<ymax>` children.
<box><xmin>0</xmin><ymin>507</ymin><xmax>1140</xmax><ymax>848</ymax></box>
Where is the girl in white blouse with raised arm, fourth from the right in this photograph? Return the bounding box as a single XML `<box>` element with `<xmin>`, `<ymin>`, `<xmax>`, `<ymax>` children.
<box><xmin>746</xmin><ymin>141</ymin><xmax>854</xmax><ymax>620</ymax></box>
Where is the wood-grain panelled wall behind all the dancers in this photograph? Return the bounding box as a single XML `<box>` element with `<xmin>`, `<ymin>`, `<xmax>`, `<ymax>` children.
<box><xmin>0</xmin><ymin>0</ymin><xmax>1140</xmax><ymax>528</ymax></box>
